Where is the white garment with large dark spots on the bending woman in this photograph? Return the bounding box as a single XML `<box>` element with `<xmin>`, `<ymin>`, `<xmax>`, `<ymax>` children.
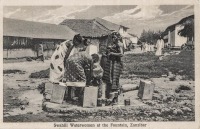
<box><xmin>49</xmin><ymin>40</ymin><xmax>71</xmax><ymax>82</ymax></box>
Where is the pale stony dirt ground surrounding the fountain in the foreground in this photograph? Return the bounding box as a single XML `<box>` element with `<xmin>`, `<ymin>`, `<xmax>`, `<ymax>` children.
<box><xmin>3</xmin><ymin>50</ymin><xmax>195</xmax><ymax>122</ymax></box>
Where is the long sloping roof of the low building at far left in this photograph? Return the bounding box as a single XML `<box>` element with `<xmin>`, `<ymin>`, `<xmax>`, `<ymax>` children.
<box><xmin>3</xmin><ymin>18</ymin><xmax>77</xmax><ymax>39</ymax></box>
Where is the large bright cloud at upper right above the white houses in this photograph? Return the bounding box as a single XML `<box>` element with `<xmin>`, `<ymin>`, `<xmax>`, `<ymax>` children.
<box><xmin>103</xmin><ymin>5</ymin><xmax>194</xmax><ymax>36</ymax></box>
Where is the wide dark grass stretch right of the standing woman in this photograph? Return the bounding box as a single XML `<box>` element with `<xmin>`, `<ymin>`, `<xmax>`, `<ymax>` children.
<box><xmin>123</xmin><ymin>51</ymin><xmax>194</xmax><ymax>80</ymax></box>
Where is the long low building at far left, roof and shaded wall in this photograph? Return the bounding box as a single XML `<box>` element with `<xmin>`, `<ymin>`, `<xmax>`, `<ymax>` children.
<box><xmin>3</xmin><ymin>18</ymin><xmax>77</xmax><ymax>58</ymax></box>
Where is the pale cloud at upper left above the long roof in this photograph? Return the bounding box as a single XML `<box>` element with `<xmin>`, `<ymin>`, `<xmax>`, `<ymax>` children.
<box><xmin>4</xmin><ymin>6</ymin><xmax>91</xmax><ymax>24</ymax></box>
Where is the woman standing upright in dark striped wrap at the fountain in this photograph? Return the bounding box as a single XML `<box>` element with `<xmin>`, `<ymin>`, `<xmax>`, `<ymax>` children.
<box><xmin>102</xmin><ymin>33</ymin><xmax>123</xmax><ymax>98</ymax></box>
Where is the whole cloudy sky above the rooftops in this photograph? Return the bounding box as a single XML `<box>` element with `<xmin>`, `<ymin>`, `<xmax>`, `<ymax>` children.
<box><xmin>3</xmin><ymin>5</ymin><xmax>194</xmax><ymax>36</ymax></box>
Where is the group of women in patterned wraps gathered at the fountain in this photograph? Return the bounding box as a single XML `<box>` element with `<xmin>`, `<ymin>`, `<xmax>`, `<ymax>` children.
<box><xmin>50</xmin><ymin>32</ymin><xmax>123</xmax><ymax>105</ymax></box>
